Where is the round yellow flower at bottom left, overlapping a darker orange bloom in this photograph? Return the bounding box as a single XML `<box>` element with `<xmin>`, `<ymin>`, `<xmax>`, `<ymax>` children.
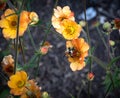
<box><xmin>8</xmin><ymin>71</ymin><xmax>27</xmax><ymax>95</ymax></box>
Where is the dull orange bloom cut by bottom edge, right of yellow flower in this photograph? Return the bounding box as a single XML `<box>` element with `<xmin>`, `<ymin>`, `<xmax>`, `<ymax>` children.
<box><xmin>20</xmin><ymin>80</ymin><xmax>41</xmax><ymax>98</ymax></box>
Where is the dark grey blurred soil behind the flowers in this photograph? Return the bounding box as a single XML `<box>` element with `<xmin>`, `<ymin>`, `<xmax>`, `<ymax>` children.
<box><xmin>0</xmin><ymin>0</ymin><xmax>120</xmax><ymax>98</ymax></box>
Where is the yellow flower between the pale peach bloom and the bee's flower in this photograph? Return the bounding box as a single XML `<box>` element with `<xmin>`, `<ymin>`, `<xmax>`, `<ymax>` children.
<box><xmin>61</xmin><ymin>19</ymin><xmax>82</xmax><ymax>40</ymax></box>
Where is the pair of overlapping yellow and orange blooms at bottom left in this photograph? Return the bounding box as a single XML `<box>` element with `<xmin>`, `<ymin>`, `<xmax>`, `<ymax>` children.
<box><xmin>8</xmin><ymin>71</ymin><xmax>41</xmax><ymax>98</ymax></box>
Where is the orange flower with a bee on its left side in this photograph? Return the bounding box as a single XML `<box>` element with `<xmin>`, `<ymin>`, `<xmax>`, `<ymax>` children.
<box><xmin>66</xmin><ymin>38</ymin><xmax>89</xmax><ymax>71</ymax></box>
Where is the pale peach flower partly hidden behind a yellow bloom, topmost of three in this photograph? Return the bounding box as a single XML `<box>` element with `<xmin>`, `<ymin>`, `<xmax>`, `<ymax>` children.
<box><xmin>52</xmin><ymin>6</ymin><xmax>75</xmax><ymax>33</ymax></box>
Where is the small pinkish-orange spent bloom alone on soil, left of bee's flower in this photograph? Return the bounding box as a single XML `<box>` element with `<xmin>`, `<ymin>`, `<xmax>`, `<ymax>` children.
<box><xmin>40</xmin><ymin>41</ymin><xmax>52</xmax><ymax>55</ymax></box>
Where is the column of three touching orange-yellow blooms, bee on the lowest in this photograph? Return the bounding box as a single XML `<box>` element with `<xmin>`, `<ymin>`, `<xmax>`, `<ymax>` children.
<box><xmin>52</xmin><ymin>6</ymin><xmax>89</xmax><ymax>71</ymax></box>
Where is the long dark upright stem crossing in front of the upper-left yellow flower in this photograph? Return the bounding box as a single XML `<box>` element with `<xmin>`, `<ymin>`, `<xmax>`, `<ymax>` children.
<box><xmin>14</xmin><ymin>14</ymin><xmax>20</xmax><ymax>74</ymax></box>
